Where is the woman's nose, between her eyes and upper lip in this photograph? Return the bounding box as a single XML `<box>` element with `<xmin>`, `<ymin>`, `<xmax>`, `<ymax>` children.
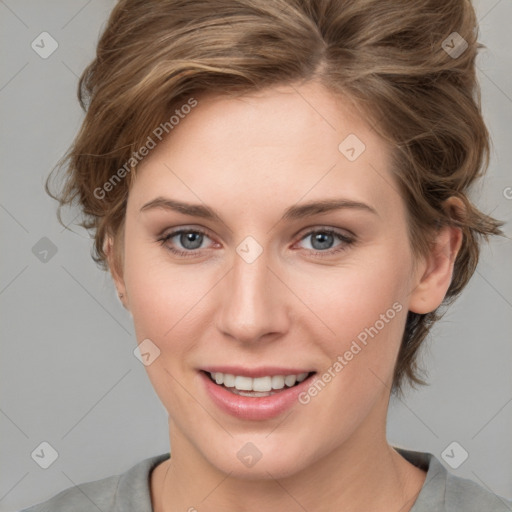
<box><xmin>217</xmin><ymin>244</ymin><xmax>290</xmax><ymax>343</ymax></box>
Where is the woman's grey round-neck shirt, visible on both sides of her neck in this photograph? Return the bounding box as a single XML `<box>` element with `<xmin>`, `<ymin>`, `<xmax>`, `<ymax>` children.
<box><xmin>21</xmin><ymin>448</ymin><xmax>512</xmax><ymax>512</ymax></box>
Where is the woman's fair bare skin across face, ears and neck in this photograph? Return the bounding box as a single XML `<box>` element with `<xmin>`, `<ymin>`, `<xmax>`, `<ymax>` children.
<box><xmin>107</xmin><ymin>82</ymin><xmax>462</xmax><ymax>512</ymax></box>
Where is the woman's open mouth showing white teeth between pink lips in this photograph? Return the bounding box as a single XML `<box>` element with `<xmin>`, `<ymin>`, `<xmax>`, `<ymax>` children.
<box><xmin>203</xmin><ymin>371</ymin><xmax>316</xmax><ymax>398</ymax></box>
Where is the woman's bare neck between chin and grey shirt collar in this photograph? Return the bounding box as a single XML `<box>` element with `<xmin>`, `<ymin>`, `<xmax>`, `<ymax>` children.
<box><xmin>152</xmin><ymin>410</ymin><xmax>425</xmax><ymax>512</ymax></box>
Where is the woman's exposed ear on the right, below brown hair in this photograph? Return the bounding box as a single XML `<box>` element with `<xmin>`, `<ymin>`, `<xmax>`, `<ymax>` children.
<box><xmin>409</xmin><ymin>197</ymin><xmax>465</xmax><ymax>314</ymax></box>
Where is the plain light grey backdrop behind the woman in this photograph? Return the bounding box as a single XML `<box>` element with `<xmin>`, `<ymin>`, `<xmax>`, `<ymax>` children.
<box><xmin>0</xmin><ymin>0</ymin><xmax>512</xmax><ymax>511</ymax></box>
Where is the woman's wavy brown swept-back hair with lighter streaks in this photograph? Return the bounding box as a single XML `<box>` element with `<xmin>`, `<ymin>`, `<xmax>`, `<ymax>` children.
<box><xmin>46</xmin><ymin>0</ymin><xmax>503</xmax><ymax>393</ymax></box>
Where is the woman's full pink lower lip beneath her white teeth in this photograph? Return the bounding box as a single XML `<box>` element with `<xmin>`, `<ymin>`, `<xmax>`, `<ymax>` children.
<box><xmin>199</xmin><ymin>371</ymin><xmax>314</xmax><ymax>420</ymax></box>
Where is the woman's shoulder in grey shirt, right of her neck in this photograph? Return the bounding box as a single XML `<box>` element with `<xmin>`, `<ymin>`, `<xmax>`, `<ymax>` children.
<box><xmin>395</xmin><ymin>447</ymin><xmax>512</xmax><ymax>512</ymax></box>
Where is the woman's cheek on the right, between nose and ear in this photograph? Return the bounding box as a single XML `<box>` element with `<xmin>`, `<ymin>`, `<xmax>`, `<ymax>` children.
<box><xmin>296</xmin><ymin>245</ymin><xmax>411</xmax><ymax>386</ymax></box>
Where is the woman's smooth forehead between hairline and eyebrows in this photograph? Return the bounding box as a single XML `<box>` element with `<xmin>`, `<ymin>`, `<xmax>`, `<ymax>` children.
<box><xmin>129</xmin><ymin>83</ymin><xmax>400</xmax><ymax>222</ymax></box>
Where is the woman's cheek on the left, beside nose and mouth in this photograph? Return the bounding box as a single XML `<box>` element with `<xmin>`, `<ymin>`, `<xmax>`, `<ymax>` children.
<box><xmin>121</xmin><ymin>244</ymin><xmax>212</xmax><ymax>416</ymax></box>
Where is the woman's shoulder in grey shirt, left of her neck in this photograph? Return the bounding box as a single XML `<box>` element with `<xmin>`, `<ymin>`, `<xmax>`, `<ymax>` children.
<box><xmin>21</xmin><ymin>453</ymin><xmax>170</xmax><ymax>512</ymax></box>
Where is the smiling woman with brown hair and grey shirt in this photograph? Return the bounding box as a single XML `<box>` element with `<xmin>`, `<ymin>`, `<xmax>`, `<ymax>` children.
<box><xmin>21</xmin><ymin>0</ymin><xmax>510</xmax><ymax>512</ymax></box>
